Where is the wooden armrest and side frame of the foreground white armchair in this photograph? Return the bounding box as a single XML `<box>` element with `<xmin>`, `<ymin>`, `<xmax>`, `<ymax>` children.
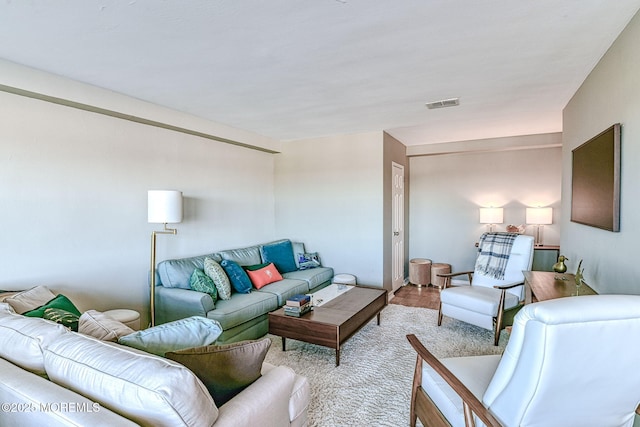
<box><xmin>407</xmin><ymin>334</ymin><xmax>502</xmax><ymax>427</ymax></box>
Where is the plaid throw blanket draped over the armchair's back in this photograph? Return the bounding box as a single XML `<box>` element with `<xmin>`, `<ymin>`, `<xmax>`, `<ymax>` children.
<box><xmin>475</xmin><ymin>233</ymin><xmax>518</xmax><ymax>280</ymax></box>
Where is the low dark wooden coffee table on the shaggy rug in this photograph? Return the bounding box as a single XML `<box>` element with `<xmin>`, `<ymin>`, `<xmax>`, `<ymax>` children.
<box><xmin>269</xmin><ymin>285</ymin><xmax>387</xmax><ymax>366</ymax></box>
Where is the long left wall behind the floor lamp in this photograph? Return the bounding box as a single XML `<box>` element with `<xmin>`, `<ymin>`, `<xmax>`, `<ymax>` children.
<box><xmin>0</xmin><ymin>63</ymin><xmax>275</xmax><ymax>324</ymax></box>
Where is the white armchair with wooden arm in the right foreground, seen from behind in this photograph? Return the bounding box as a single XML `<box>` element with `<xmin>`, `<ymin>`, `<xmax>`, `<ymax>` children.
<box><xmin>407</xmin><ymin>295</ymin><xmax>640</xmax><ymax>427</ymax></box>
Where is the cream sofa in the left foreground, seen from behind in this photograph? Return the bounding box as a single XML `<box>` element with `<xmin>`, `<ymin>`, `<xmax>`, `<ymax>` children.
<box><xmin>0</xmin><ymin>303</ymin><xmax>309</xmax><ymax>427</ymax></box>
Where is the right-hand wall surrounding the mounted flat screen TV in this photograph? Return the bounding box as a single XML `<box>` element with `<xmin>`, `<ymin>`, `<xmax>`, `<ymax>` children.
<box><xmin>561</xmin><ymin>10</ymin><xmax>640</xmax><ymax>294</ymax></box>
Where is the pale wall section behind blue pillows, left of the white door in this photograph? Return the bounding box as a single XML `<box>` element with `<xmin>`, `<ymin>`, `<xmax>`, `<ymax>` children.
<box><xmin>275</xmin><ymin>132</ymin><xmax>383</xmax><ymax>286</ymax></box>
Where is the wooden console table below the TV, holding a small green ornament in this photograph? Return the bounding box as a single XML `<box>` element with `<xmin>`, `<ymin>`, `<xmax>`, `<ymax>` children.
<box><xmin>523</xmin><ymin>271</ymin><xmax>597</xmax><ymax>304</ymax></box>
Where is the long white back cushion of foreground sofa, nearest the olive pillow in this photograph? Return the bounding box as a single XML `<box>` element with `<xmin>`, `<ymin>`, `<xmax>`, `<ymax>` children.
<box><xmin>44</xmin><ymin>332</ymin><xmax>218</xmax><ymax>427</ymax></box>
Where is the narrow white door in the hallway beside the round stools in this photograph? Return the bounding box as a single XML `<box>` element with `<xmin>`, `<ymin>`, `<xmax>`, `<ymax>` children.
<box><xmin>391</xmin><ymin>163</ymin><xmax>404</xmax><ymax>292</ymax></box>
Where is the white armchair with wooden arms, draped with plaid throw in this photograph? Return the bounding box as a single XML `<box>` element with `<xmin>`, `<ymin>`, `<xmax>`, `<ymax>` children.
<box><xmin>438</xmin><ymin>233</ymin><xmax>533</xmax><ymax>345</ymax></box>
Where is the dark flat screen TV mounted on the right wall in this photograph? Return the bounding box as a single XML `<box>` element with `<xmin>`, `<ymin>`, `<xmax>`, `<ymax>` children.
<box><xmin>571</xmin><ymin>123</ymin><xmax>620</xmax><ymax>231</ymax></box>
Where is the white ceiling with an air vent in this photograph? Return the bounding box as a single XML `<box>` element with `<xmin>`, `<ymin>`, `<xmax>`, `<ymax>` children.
<box><xmin>0</xmin><ymin>0</ymin><xmax>640</xmax><ymax>145</ymax></box>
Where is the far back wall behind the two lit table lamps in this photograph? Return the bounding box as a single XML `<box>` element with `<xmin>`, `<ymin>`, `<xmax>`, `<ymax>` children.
<box><xmin>409</xmin><ymin>140</ymin><xmax>562</xmax><ymax>271</ymax></box>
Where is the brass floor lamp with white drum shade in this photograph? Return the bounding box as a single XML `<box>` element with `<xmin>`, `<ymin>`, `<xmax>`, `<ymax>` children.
<box><xmin>147</xmin><ymin>190</ymin><xmax>182</xmax><ymax>326</ymax></box>
